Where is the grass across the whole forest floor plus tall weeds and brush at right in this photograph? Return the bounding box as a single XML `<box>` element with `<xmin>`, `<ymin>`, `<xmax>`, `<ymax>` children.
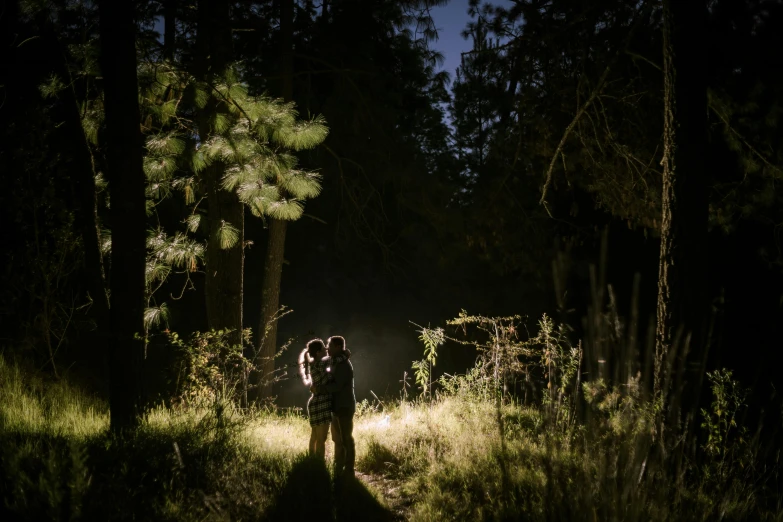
<box><xmin>0</xmin><ymin>286</ymin><xmax>783</xmax><ymax>522</ymax></box>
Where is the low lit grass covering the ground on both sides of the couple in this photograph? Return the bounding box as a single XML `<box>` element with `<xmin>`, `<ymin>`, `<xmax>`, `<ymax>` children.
<box><xmin>0</xmin><ymin>350</ymin><xmax>783</xmax><ymax>521</ymax></box>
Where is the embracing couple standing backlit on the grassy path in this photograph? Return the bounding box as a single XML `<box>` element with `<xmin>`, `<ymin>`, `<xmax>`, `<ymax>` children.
<box><xmin>299</xmin><ymin>335</ymin><xmax>356</xmax><ymax>477</ymax></box>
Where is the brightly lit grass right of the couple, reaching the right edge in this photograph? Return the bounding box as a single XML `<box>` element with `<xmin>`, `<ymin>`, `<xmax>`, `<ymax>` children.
<box><xmin>357</xmin><ymin>386</ymin><xmax>783</xmax><ymax>521</ymax></box>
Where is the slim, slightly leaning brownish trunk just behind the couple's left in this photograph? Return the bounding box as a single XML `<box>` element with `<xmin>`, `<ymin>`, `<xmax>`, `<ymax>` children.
<box><xmin>258</xmin><ymin>0</ymin><xmax>294</xmax><ymax>397</ymax></box>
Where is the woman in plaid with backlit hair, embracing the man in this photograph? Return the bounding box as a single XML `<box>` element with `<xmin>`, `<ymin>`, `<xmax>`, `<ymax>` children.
<box><xmin>299</xmin><ymin>339</ymin><xmax>332</xmax><ymax>459</ymax></box>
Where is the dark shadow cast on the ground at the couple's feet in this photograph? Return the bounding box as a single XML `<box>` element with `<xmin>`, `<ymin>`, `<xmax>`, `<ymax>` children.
<box><xmin>266</xmin><ymin>457</ymin><xmax>395</xmax><ymax>522</ymax></box>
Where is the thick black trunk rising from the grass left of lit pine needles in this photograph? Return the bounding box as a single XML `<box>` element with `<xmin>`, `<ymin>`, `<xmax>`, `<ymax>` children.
<box><xmin>98</xmin><ymin>0</ymin><xmax>146</xmax><ymax>432</ymax></box>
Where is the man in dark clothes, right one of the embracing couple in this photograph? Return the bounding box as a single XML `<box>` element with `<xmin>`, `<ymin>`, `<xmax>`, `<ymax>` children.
<box><xmin>310</xmin><ymin>335</ymin><xmax>356</xmax><ymax>477</ymax></box>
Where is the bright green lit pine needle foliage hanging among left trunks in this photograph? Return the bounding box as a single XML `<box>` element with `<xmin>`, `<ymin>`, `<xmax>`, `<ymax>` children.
<box><xmin>133</xmin><ymin>62</ymin><xmax>328</xmax><ymax>328</ymax></box>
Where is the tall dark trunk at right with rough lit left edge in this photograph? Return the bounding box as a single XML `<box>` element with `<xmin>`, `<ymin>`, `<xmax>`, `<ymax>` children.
<box><xmin>655</xmin><ymin>0</ymin><xmax>709</xmax><ymax>414</ymax></box>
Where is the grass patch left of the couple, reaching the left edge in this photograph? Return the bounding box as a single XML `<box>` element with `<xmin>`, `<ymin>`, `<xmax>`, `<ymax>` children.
<box><xmin>0</xmin><ymin>356</ymin><xmax>298</xmax><ymax>520</ymax></box>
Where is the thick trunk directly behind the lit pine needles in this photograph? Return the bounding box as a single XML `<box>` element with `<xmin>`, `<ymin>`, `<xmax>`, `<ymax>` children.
<box><xmin>196</xmin><ymin>0</ymin><xmax>245</xmax><ymax>344</ymax></box>
